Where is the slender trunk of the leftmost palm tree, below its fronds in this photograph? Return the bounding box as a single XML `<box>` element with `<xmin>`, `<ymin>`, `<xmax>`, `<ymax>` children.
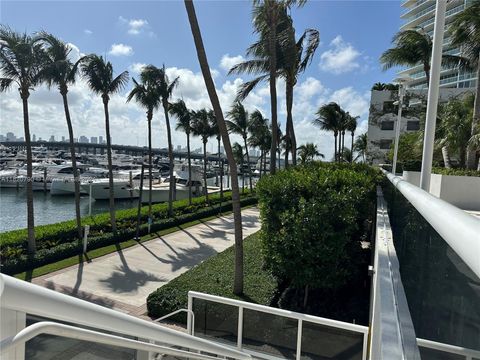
<box><xmin>20</xmin><ymin>89</ymin><xmax>37</xmax><ymax>255</ymax></box>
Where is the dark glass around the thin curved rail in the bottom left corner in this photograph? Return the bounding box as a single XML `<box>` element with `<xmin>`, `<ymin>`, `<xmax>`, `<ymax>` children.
<box><xmin>25</xmin><ymin>315</ymin><xmax>136</xmax><ymax>360</ymax></box>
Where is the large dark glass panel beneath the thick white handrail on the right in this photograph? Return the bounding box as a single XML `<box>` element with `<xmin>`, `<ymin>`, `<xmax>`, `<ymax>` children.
<box><xmin>384</xmin><ymin>180</ymin><xmax>480</xmax><ymax>350</ymax></box>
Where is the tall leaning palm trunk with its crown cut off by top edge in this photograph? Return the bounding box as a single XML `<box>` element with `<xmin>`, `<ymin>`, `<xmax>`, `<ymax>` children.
<box><xmin>184</xmin><ymin>0</ymin><xmax>243</xmax><ymax>295</ymax></box>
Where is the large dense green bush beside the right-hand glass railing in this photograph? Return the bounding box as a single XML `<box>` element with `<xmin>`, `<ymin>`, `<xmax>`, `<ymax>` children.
<box><xmin>257</xmin><ymin>163</ymin><xmax>381</xmax><ymax>289</ymax></box>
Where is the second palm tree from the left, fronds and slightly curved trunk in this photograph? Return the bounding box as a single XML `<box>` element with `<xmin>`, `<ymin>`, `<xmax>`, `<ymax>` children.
<box><xmin>36</xmin><ymin>32</ymin><xmax>82</xmax><ymax>239</ymax></box>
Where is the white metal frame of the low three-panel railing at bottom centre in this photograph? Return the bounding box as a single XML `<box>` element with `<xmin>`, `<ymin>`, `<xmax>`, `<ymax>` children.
<box><xmin>187</xmin><ymin>291</ymin><xmax>368</xmax><ymax>360</ymax></box>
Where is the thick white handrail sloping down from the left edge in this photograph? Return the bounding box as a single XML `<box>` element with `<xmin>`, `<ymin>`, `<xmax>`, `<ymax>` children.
<box><xmin>0</xmin><ymin>274</ymin><xmax>251</xmax><ymax>360</ymax></box>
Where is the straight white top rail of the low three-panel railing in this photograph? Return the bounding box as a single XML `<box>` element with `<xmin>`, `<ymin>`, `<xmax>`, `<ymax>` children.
<box><xmin>188</xmin><ymin>291</ymin><xmax>368</xmax><ymax>334</ymax></box>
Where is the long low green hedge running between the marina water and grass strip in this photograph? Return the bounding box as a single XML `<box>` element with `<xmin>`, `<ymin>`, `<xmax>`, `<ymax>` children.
<box><xmin>0</xmin><ymin>193</ymin><xmax>257</xmax><ymax>274</ymax></box>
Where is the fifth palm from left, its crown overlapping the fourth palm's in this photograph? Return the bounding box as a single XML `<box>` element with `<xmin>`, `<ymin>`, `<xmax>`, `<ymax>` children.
<box><xmin>143</xmin><ymin>65</ymin><xmax>179</xmax><ymax>216</ymax></box>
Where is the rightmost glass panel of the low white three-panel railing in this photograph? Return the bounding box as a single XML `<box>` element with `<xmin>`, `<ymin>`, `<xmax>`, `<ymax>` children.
<box><xmin>301</xmin><ymin>321</ymin><xmax>364</xmax><ymax>360</ymax></box>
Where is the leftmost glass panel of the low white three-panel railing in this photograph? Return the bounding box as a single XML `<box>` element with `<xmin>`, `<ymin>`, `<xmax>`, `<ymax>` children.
<box><xmin>193</xmin><ymin>299</ymin><xmax>238</xmax><ymax>344</ymax></box>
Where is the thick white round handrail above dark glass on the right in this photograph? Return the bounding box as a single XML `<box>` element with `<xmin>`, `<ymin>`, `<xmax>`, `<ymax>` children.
<box><xmin>383</xmin><ymin>170</ymin><xmax>480</xmax><ymax>277</ymax></box>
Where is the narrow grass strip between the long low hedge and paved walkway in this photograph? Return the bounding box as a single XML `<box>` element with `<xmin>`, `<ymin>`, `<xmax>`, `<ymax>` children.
<box><xmin>14</xmin><ymin>206</ymin><xmax>253</xmax><ymax>281</ymax></box>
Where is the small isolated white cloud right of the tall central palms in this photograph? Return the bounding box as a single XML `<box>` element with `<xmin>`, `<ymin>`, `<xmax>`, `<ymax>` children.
<box><xmin>320</xmin><ymin>35</ymin><xmax>361</xmax><ymax>74</ymax></box>
